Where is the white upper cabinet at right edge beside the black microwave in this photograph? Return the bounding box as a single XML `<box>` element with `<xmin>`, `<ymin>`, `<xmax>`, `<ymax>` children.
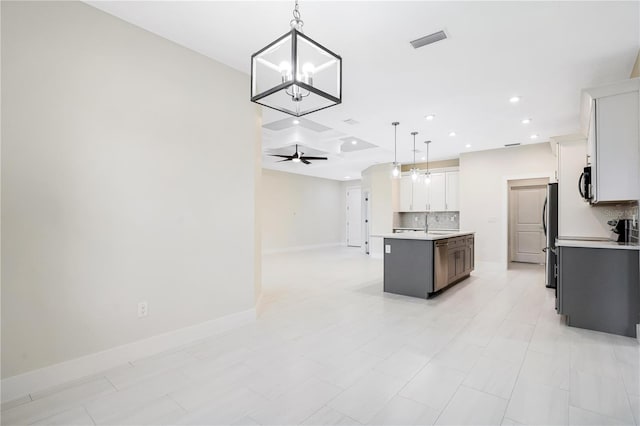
<box><xmin>584</xmin><ymin>79</ymin><xmax>640</xmax><ymax>203</ymax></box>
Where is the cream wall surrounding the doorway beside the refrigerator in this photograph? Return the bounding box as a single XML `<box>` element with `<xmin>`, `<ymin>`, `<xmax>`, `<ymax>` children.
<box><xmin>460</xmin><ymin>143</ymin><xmax>555</xmax><ymax>264</ymax></box>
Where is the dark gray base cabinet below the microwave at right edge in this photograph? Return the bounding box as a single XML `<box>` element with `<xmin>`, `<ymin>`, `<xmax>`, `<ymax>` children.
<box><xmin>558</xmin><ymin>247</ymin><xmax>640</xmax><ymax>337</ymax></box>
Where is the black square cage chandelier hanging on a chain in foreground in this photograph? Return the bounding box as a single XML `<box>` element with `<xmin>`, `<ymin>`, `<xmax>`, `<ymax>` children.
<box><xmin>251</xmin><ymin>0</ymin><xmax>342</xmax><ymax>117</ymax></box>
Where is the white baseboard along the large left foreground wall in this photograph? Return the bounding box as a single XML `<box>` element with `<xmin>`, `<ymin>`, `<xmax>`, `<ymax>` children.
<box><xmin>0</xmin><ymin>308</ymin><xmax>256</xmax><ymax>402</ymax></box>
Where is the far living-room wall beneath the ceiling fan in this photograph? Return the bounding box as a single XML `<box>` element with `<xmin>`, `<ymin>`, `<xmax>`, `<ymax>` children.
<box><xmin>261</xmin><ymin>169</ymin><xmax>346</xmax><ymax>253</ymax></box>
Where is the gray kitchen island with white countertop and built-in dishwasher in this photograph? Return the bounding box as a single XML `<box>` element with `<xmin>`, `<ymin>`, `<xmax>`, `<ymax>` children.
<box><xmin>377</xmin><ymin>231</ymin><xmax>474</xmax><ymax>299</ymax></box>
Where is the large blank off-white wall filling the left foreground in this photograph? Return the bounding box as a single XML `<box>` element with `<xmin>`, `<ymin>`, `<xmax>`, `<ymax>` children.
<box><xmin>2</xmin><ymin>2</ymin><xmax>260</xmax><ymax>380</ymax></box>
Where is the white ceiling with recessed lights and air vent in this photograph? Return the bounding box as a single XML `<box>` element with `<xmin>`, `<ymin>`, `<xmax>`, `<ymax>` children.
<box><xmin>89</xmin><ymin>0</ymin><xmax>640</xmax><ymax>180</ymax></box>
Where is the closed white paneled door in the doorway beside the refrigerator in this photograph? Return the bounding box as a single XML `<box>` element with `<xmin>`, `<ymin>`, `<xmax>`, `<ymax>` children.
<box><xmin>509</xmin><ymin>186</ymin><xmax>547</xmax><ymax>263</ymax></box>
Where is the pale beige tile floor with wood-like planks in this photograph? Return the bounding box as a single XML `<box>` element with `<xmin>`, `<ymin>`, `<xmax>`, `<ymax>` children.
<box><xmin>2</xmin><ymin>248</ymin><xmax>640</xmax><ymax>425</ymax></box>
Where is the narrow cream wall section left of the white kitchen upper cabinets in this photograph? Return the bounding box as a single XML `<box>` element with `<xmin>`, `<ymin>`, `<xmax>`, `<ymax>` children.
<box><xmin>362</xmin><ymin>163</ymin><xmax>398</xmax><ymax>258</ymax></box>
